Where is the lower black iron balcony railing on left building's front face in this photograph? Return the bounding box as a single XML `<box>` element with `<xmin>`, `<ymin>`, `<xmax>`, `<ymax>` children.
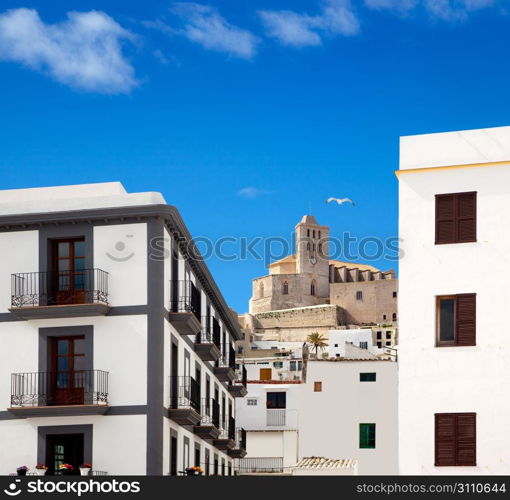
<box><xmin>11</xmin><ymin>370</ymin><xmax>109</xmax><ymax>408</ymax></box>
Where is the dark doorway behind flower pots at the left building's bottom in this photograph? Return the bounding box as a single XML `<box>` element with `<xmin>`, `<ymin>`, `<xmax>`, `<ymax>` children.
<box><xmin>46</xmin><ymin>434</ymin><xmax>84</xmax><ymax>475</ymax></box>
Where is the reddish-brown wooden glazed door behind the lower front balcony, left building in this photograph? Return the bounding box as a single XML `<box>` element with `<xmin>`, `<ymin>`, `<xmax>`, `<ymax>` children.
<box><xmin>50</xmin><ymin>336</ymin><xmax>88</xmax><ymax>406</ymax></box>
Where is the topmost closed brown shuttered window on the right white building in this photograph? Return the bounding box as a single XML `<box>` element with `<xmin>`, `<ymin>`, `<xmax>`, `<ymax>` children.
<box><xmin>436</xmin><ymin>192</ymin><xmax>476</xmax><ymax>245</ymax></box>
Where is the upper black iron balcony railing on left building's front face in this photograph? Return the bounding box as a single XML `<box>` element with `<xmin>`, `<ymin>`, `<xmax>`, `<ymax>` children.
<box><xmin>11</xmin><ymin>269</ymin><xmax>109</xmax><ymax>307</ymax></box>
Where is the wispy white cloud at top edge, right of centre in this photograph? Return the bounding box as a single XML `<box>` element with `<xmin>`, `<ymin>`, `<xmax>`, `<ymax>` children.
<box><xmin>259</xmin><ymin>0</ymin><xmax>359</xmax><ymax>47</ymax></box>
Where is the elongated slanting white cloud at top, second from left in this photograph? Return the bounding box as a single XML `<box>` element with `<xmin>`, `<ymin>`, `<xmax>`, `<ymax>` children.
<box><xmin>172</xmin><ymin>2</ymin><xmax>259</xmax><ymax>59</ymax></box>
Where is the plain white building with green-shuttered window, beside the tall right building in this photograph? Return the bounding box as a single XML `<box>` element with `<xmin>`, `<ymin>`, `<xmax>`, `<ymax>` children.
<box><xmin>299</xmin><ymin>358</ymin><xmax>398</xmax><ymax>475</ymax></box>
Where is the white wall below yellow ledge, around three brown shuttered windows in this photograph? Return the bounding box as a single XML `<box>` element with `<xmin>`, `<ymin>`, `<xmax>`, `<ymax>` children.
<box><xmin>399</xmin><ymin>159</ymin><xmax>510</xmax><ymax>474</ymax></box>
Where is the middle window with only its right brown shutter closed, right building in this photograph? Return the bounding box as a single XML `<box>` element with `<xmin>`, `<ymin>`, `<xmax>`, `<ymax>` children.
<box><xmin>436</xmin><ymin>293</ymin><xmax>476</xmax><ymax>346</ymax></box>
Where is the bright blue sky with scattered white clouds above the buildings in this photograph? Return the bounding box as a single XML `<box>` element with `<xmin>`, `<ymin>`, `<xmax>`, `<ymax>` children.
<box><xmin>0</xmin><ymin>0</ymin><xmax>510</xmax><ymax>312</ymax></box>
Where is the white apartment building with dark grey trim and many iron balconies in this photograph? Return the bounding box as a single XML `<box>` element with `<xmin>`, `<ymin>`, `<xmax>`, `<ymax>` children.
<box><xmin>0</xmin><ymin>183</ymin><xmax>246</xmax><ymax>475</ymax></box>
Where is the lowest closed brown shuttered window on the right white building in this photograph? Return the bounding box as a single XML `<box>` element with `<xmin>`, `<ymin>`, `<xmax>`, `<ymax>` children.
<box><xmin>434</xmin><ymin>413</ymin><xmax>476</xmax><ymax>467</ymax></box>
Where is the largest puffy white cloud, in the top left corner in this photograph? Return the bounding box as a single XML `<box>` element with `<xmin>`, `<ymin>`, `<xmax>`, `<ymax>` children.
<box><xmin>0</xmin><ymin>8</ymin><xmax>137</xmax><ymax>94</ymax></box>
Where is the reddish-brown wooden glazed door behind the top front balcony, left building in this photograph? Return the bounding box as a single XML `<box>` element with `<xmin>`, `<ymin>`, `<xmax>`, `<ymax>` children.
<box><xmin>52</xmin><ymin>238</ymin><xmax>86</xmax><ymax>305</ymax></box>
